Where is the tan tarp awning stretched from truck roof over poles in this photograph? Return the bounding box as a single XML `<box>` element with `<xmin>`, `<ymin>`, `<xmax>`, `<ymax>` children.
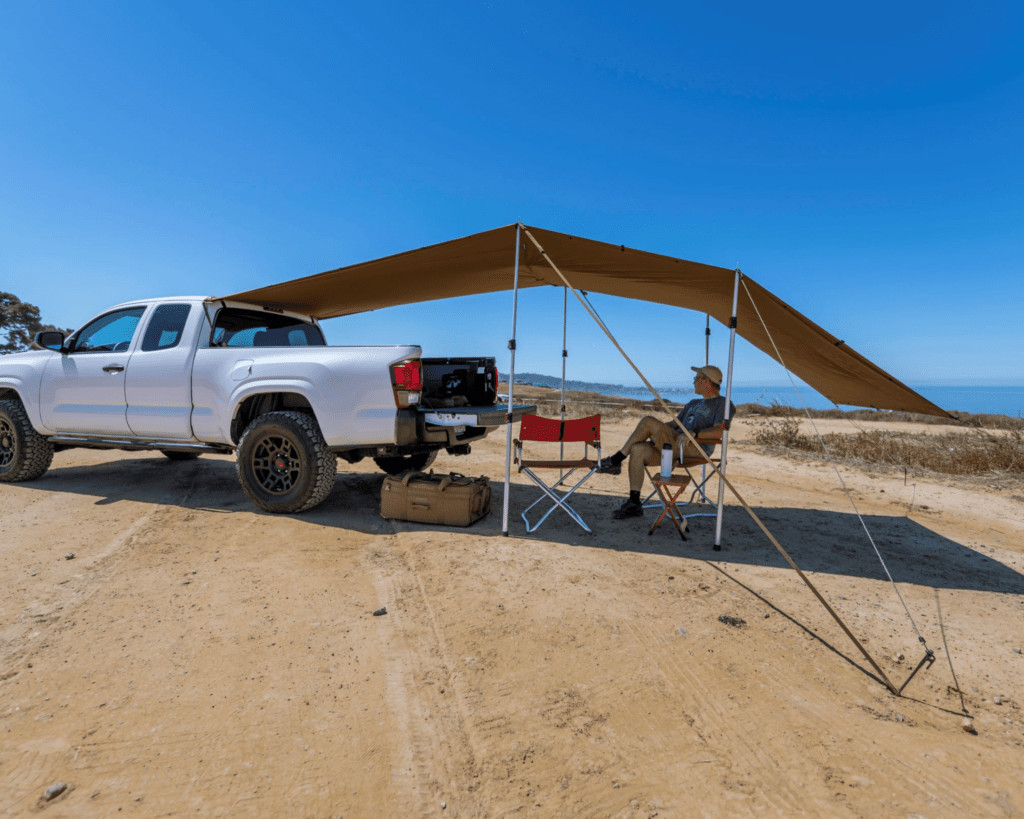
<box><xmin>223</xmin><ymin>224</ymin><xmax>947</xmax><ymax>416</ymax></box>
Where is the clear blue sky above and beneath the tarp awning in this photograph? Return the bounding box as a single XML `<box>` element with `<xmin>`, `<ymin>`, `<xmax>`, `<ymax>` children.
<box><xmin>0</xmin><ymin>0</ymin><xmax>1024</xmax><ymax>385</ymax></box>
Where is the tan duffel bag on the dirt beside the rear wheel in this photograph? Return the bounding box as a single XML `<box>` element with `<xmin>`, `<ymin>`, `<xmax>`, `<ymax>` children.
<box><xmin>381</xmin><ymin>470</ymin><xmax>490</xmax><ymax>526</ymax></box>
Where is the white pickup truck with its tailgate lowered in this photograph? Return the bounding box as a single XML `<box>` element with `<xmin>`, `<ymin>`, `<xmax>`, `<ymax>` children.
<box><xmin>0</xmin><ymin>296</ymin><xmax>534</xmax><ymax>512</ymax></box>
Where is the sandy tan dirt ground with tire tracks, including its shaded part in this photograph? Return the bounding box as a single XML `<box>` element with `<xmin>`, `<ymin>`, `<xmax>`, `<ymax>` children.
<box><xmin>0</xmin><ymin>419</ymin><xmax>1024</xmax><ymax>819</ymax></box>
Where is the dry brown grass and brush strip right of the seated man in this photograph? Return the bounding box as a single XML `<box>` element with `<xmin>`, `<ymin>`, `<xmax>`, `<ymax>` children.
<box><xmin>752</xmin><ymin>417</ymin><xmax>1024</xmax><ymax>479</ymax></box>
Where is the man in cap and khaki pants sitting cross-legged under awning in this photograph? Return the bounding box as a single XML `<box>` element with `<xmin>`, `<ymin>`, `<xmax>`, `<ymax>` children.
<box><xmin>597</xmin><ymin>365</ymin><xmax>736</xmax><ymax>520</ymax></box>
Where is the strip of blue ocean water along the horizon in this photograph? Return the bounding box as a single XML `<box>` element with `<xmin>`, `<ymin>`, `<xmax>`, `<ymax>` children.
<box><xmin>594</xmin><ymin>385</ymin><xmax>1024</xmax><ymax>418</ymax></box>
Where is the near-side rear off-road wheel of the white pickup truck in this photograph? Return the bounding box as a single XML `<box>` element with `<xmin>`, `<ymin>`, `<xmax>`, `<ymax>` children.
<box><xmin>237</xmin><ymin>412</ymin><xmax>338</xmax><ymax>514</ymax></box>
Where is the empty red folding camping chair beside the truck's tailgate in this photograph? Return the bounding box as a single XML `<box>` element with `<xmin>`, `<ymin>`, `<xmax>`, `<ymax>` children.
<box><xmin>514</xmin><ymin>415</ymin><xmax>601</xmax><ymax>532</ymax></box>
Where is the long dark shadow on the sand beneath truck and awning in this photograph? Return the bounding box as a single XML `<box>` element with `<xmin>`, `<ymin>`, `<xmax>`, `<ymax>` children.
<box><xmin>25</xmin><ymin>457</ymin><xmax>1024</xmax><ymax>595</ymax></box>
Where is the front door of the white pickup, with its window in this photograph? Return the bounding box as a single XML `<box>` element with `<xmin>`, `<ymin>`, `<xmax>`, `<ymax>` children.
<box><xmin>39</xmin><ymin>306</ymin><xmax>145</xmax><ymax>435</ymax></box>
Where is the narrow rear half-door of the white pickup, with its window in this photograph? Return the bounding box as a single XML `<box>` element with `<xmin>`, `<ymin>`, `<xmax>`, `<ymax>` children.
<box><xmin>125</xmin><ymin>304</ymin><xmax>196</xmax><ymax>438</ymax></box>
